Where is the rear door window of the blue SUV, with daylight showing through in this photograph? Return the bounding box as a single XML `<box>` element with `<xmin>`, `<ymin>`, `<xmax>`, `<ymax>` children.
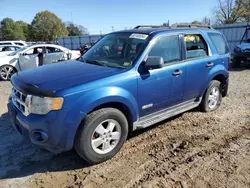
<box><xmin>184</xmin><ymin>34</ymin><xmax>208</xmax><ymax>59</ymax></box>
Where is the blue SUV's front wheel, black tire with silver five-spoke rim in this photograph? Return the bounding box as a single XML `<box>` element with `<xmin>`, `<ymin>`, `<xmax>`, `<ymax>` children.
<box><xmin>74</xmin><ymin>108</ymin><xmax>128</xmax><ymax>164</ymax></box>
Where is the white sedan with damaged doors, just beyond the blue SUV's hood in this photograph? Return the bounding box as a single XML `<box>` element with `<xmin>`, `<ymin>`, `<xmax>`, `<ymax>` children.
<box><xmin>0</xmin><ymin>44</ymin><xmax>80</xmax><ymax>80</ymax></box>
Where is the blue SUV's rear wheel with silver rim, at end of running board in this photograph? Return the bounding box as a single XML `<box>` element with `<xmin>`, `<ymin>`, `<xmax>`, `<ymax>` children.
<box><xmin>200</xmin><ymin>80</ymin><xmax>222</xmax><ymax>112</ymax></box>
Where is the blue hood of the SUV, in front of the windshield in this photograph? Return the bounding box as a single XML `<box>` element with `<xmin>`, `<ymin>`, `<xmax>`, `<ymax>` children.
<box><xmin>17</xmin><ymin>60</ymin><xmax>124</xmax><ymax>91</ymax></box>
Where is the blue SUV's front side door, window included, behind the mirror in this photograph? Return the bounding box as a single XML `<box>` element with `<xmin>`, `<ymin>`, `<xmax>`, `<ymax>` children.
<box><xmin>138</xmin><ymin>35</ymin><xmax>186</xmax><ymax>117</ymax></box>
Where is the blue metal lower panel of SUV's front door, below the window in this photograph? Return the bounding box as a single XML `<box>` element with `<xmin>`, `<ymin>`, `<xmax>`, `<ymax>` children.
<box><xmin>138</xmin><ymin>63</ymin><xmax>186</xmax><ymax>117</ymax></box>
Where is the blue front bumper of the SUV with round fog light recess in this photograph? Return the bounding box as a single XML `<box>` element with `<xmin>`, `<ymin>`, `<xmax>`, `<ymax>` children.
<box><xmin>8</xmin><ymin>99</ymin><xmax>76</xmax><ymax>153</ymax></box>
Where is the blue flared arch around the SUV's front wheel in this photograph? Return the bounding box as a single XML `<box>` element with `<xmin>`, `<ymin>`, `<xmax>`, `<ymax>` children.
<box><xmin>63</xmin><ymin>87</ymin><xmax>138</xmax><ymax>148</ymax></box>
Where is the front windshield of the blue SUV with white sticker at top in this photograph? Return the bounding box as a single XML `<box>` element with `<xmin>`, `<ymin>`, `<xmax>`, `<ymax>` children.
<box><xmin>79</xmin><ymin>33</ymin><xmax>148</xmax><ymax>68</ymax></box>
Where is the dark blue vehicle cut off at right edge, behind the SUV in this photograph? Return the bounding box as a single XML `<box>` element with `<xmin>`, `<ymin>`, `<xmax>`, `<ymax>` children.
<box><xmin>233</xmin><ymin>39</ymin><xmax>250</xmax><ymax>68</ymax></box>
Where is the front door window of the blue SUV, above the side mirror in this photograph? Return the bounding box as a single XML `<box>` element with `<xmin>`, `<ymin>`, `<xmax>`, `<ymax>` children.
<box><xmin>149</xmin><ymin>36</ymin><xmax>181</xmax><ymax>64</ymax></box>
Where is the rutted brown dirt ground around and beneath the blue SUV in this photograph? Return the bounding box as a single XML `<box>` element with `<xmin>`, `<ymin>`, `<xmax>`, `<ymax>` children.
<box><xmin>0</xmin><ymin>69</ymin><xmax>250</xmax><ymax>188</ymax></box>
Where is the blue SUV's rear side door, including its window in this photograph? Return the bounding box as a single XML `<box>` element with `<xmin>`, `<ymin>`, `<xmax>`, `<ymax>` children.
<box><xmin>183</xmin><ymin>33</ymin><xmax>215</xmax><ymax>101</ymax></box>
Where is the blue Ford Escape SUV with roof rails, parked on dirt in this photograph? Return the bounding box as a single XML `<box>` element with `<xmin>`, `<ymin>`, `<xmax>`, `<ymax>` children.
<box><xmin>8</xmin><ymin>25</ymin><xmax>230</xmax><ymax>163</ymax></box>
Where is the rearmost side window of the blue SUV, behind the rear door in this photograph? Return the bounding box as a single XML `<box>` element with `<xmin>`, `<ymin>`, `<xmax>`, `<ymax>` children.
<box><xmin>208</xmin><ymin>33</ymin><xmax>229</xmax><ymax>54</ymax></box>
